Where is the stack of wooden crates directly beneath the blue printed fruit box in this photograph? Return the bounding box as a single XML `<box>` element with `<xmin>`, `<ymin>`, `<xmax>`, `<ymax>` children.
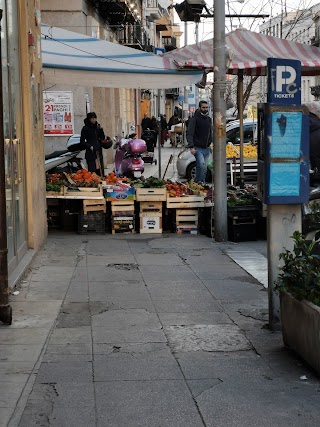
<box><xmin>111</xmin><ymin>200</ymin><xmax>135</xmax><ymax>234</ymax></box>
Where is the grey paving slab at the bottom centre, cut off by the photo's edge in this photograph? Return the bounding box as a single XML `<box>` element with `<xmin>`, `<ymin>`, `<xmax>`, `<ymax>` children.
<box><xmin>95</xmin><ymin>380</ymin><xmax>203</xmax><ymax>427</ymax></box>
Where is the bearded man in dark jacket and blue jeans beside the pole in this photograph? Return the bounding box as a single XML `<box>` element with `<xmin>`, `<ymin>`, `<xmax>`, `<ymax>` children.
<box><xmin>187</xmin><ymin>101</ymin><xmax>212</xmax><ymax>182</ymax></box>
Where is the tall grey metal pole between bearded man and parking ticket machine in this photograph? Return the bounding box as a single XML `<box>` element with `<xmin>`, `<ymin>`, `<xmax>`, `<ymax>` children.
<box><xmin>213</xmin><ymin>0</ymin><xmax>228</xmax><ymax>242</ymax></box>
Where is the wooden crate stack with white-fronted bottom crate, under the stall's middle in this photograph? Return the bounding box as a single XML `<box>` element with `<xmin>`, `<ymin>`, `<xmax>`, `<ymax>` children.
<box><xmin>136</xmin><ymin>188</ymin><xmax>167</xmax><ymax>233</ymax></box>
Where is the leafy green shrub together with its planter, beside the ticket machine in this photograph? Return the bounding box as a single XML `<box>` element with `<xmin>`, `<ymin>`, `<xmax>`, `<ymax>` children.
<box><xmin>276</xmin><ymin>231</ymin><xmax>320</xmax><ymax>374</ymax></box>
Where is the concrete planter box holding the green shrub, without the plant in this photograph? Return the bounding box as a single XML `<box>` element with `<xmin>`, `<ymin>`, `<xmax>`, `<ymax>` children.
<box><xmin>281</xmin><ymin>293</ymin><xmax>320</xmax><ymax>374</ymax></box>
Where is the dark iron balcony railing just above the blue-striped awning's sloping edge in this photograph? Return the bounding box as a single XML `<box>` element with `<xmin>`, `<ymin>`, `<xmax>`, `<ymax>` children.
<box><xmin>116</xmin><ymin>24</ymin><xmax>152</xmax><ymax>52</ymax></box>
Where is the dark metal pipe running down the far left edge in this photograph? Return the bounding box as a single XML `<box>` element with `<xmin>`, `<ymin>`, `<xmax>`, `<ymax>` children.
<box><xmin>0</xmin><ymin>9</ymin><xmax>12</xmax><ymax>325</ymax></box>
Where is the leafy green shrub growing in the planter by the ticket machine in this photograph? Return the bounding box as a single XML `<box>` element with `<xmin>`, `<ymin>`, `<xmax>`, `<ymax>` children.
<box><xmin>275</xmin><ymin>231</ymin><xmax>320</xmax><ymax>306</ymax></box>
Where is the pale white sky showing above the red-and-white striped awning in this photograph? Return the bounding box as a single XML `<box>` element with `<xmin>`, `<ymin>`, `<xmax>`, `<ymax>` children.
<box><xmin>174</xmin><ymin>0</ymin><xmax>320</xmax><ymax>47</ymax></box>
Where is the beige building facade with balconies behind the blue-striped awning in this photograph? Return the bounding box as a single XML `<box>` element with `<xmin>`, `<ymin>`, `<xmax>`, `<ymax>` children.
<box><xmin>41</xmin><ymin>0</ymin><xmax>177</xmax><ymax>163</ymax></box>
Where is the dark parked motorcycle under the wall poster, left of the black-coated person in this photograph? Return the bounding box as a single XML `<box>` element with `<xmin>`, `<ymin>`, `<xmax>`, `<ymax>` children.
<box><xmin>45</xmin><ymin>134</ymin><xmax>84</xmax><ymax>173</ymax></box>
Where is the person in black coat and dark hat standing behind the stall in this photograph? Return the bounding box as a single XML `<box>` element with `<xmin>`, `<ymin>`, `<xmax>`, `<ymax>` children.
<box><xmin>80</xmin><ymin>112</ymin><xmax>105</xmax><ymax>175</ymax></box>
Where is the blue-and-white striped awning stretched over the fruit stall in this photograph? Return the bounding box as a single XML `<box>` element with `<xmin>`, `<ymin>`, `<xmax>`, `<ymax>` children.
<box><xmin>41</xmin><ymin>25</ymin><xmax>203</xmax><ymax>89</ymax></box>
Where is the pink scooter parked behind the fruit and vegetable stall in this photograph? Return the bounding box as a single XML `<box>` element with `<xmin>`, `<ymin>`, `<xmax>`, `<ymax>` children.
<box><xmin>114</xmin><ymin>138</ymin><xmax>147</xmax><ymax>178</ymax></box>
